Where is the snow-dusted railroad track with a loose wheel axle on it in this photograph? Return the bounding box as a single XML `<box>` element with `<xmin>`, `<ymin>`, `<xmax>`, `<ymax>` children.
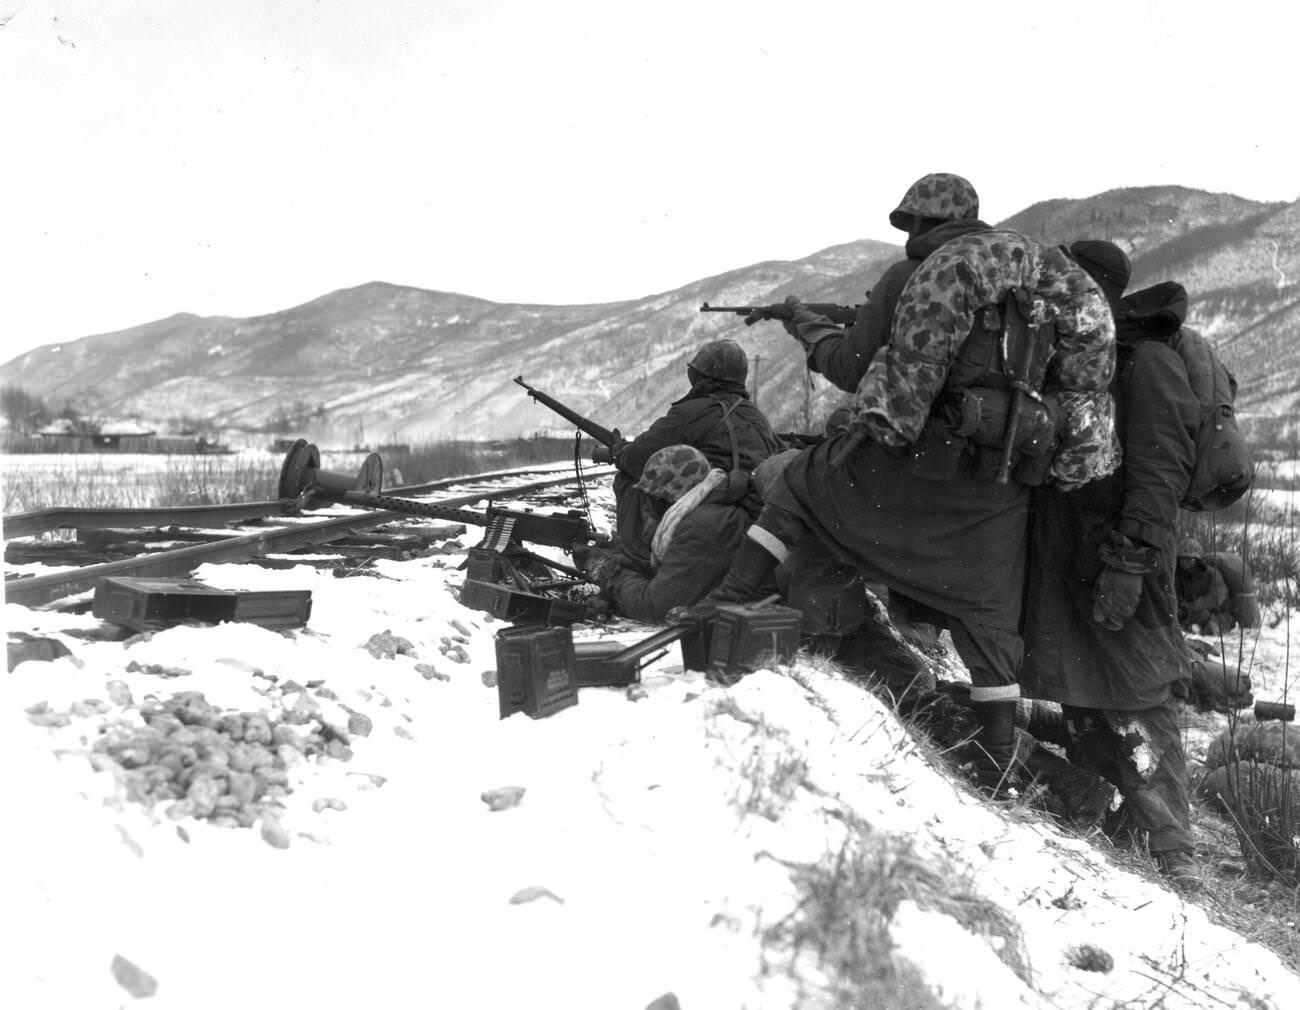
<box><xmin>4</xmin><ymin>441</ymin><xmax>612</xmax><ymax>606</ymax></box>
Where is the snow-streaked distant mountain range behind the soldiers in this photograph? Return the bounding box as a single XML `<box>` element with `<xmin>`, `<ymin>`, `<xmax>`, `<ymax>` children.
<box><xmin>0</xmin><ymin>186</ymin><xmax>1300</xmax><ymax>445</ymax></box>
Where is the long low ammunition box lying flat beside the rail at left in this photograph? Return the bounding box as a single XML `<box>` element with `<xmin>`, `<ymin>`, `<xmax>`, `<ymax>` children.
<box><xmin>91</xmin><ymin>577</ymin><xmax>312</xmax><ymax>632</ymax></box>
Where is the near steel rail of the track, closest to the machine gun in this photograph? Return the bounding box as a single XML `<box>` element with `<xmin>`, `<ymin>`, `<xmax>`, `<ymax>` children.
<box><xmin>4</xmin><ymin>471</ymin><xmax>608</xmax><ymax>607</ymax></box>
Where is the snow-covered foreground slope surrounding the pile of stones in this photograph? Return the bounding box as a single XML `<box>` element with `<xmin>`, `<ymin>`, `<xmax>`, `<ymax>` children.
<box><xmin>0</xmin><ymin>491</ymin><xmax>1300</xmax><ymax>1010</ymax></box>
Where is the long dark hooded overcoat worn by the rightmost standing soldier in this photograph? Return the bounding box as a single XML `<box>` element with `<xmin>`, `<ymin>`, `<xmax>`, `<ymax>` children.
<box><xmin>1021</xmin><ymin>285</ymin><xmax>1200</xmax><ymax>711</ymax></box>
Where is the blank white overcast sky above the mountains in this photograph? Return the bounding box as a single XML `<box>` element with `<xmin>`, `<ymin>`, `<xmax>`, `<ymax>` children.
<box><xmin>0</xmin><ymin>0</ymin><xmax>1300</xmax><ymax>360</ymax></box>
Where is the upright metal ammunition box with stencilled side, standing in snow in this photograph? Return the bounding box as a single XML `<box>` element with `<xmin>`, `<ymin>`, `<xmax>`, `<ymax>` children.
<box><xmin>497</xmin><ymin>625</ymin><xmax>577</xmax><ymax>719</ymax></box>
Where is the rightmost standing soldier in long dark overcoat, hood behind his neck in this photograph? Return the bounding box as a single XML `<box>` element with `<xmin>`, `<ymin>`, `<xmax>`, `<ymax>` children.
<box><xmin>1022</xmin><ymin>248</ymin><xmax>1200</xmax><ymax>884</ymax></box>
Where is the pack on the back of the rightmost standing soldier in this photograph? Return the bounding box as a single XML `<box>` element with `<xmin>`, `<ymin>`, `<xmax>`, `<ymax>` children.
<box><xmin>1169</xmin><ymin>326</ymin><xmax>1255</xmax><ymax>512</ymax></box>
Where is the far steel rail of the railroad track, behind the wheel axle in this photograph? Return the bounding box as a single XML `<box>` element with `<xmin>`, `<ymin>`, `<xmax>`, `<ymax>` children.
<box><xmin>0</xmin><ymin>467</ymin><xmax>611</xmax><ymax>539</ymax></box>
